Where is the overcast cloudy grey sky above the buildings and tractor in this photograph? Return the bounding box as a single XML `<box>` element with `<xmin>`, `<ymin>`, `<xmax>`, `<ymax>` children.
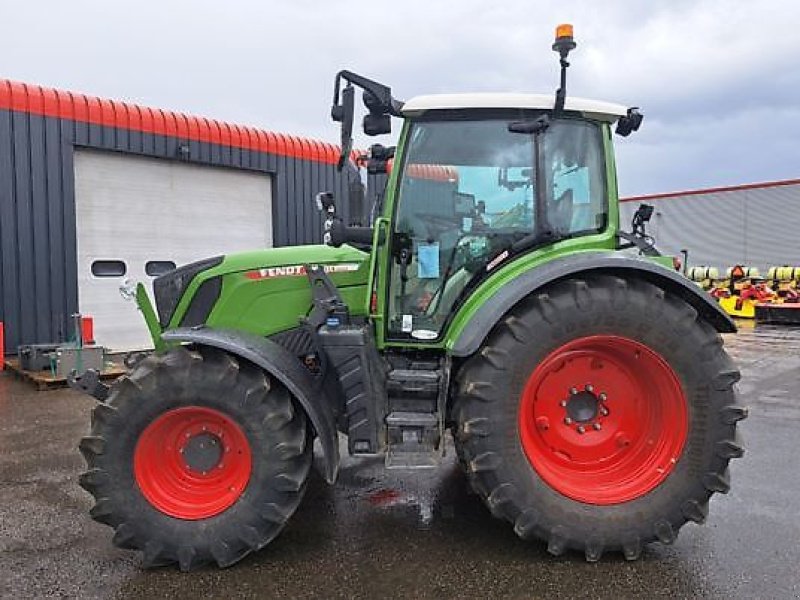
<box><xmin>0</xmin><ymin>0</ymin><xmax>800</xmax><ymax>195</ymax></box>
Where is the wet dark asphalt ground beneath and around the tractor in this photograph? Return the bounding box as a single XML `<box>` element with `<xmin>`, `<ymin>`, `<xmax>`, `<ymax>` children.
<box><xmin>0</xmin><ymin>327</ymin><xmax>800</xmax><ymax>599</ymax></box>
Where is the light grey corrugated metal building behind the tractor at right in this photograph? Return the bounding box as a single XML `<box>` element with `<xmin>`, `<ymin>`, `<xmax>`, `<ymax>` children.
<box><xmin>620</xmin><ymin>179</ymin><xmax>800</xmax><ymax>274</ymax></box>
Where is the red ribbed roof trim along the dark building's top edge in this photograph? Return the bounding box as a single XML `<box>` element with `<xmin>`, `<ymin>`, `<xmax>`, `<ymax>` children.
<box><xmin>0</xmin><ymin>79</ymin><xmax>339</xmax><ymax>164</ymax></box>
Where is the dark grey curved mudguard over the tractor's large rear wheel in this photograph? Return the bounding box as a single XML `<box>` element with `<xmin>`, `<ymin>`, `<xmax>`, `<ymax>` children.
<box><xmin>450</xmin><ymin>252</ymin><xmax>736</xmax><ymax>356</ymax></box>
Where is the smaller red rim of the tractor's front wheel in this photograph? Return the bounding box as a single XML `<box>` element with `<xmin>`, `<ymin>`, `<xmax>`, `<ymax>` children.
<box><xmin>133</xmin><ymin>406</ymin><xmax>252</xmax><ymax>520</ymax></box>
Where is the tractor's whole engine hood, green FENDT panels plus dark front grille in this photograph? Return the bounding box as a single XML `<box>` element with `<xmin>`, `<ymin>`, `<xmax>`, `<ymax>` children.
<box><xmin>155</xmin><ymin>246</ymin><xmax>369</xmax><ymax>336</ymax></box>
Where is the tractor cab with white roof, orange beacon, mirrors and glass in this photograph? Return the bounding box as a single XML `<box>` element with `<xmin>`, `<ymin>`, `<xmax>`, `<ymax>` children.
<box><xmin>319</xmin><ymin>26</ymin><xmax>652</xmax><ymax>344</ymax></box>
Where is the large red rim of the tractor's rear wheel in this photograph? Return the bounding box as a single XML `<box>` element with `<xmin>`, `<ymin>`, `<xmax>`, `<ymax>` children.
<box><xmin>519</xmin><ymin>335</ymin><xmax>689</xmax><ymax>505</ymax></box>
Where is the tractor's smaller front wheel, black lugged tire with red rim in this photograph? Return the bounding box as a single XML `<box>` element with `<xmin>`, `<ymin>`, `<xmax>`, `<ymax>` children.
<box><xmin>80</xmin><ymin>347</ymin><xmax>311</xmax><ymax>571</ymax></box>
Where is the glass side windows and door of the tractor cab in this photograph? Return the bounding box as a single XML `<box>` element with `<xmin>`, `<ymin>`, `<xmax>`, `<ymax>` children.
<box><xmin>387</xmin><ymin>117</ymin><xmax>608</xmax><ymax>340</ymax></box>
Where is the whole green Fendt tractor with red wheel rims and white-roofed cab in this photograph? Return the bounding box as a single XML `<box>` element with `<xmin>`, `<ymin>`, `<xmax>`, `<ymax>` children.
<box><xmin>73</xmin><ymin>26</ymin><xmax>746</xmax><ymax>570</ymax></box>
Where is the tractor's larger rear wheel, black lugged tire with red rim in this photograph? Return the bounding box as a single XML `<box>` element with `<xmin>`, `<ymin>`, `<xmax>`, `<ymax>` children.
<box><xmin>452</xmin><ymin>275</ymin><xmax>746</xmax><ymax>561</ymax></box>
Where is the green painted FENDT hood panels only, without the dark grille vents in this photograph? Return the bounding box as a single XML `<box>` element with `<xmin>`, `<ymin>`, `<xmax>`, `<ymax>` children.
<box><xmin>170</xmin><ymin>246</ymin><xmax>369</xmax><ymax>336</ymax></box>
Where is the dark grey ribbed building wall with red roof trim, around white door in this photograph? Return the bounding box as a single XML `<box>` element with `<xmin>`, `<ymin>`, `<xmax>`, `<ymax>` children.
<box><xmin>0</xmin><ymin>86</ymin><xmax>359</xmax><ymax>353</ymax></box>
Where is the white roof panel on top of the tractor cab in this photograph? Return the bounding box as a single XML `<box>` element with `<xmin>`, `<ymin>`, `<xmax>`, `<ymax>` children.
<box><xmin>402</xmin><ymin>93</ymin><xmax>628</xmax><ymax>122</ymax></box>
